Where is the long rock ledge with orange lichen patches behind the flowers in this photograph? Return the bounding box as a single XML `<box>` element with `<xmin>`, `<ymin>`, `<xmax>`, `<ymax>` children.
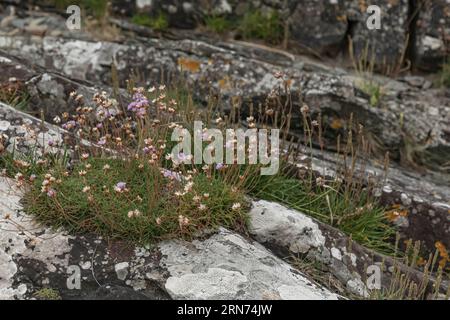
<box><xmin>0</xmin><ymin>33</ymin><xmax>450</xmax><ymax>172</ymax></box>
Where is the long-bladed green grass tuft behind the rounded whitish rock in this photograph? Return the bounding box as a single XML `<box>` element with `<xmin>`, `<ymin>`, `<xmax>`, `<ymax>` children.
<box><xmin>252</xmin><ymin>174</ymin><xmax>395</xmax><ymax>254</ymax></box>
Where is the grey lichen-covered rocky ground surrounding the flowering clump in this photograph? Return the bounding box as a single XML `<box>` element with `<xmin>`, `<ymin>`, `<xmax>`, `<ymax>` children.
<box><xmin>0</xmin><ymin>0</ymin><xmax>450</xmax><ymax>300</ymax></box>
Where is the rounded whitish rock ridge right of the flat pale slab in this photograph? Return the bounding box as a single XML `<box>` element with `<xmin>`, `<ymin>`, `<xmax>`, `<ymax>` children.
<box><xmin>250</xmin><ymin>200</ymin><xmax>448</xmax><ymax>297</ymax></box>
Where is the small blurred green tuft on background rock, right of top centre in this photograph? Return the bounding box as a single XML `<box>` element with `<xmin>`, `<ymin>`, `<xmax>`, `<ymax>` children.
<box><xmin>238</xmin><ymin>10</ymin><xmax>284</xmax><ymax>44</ymax></box>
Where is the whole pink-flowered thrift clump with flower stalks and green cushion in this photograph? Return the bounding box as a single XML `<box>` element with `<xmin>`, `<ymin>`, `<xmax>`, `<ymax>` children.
<box><xmin>20</xmin><ymin>86</ymin><xmax>247</xmax><ymax>243</ymax></box>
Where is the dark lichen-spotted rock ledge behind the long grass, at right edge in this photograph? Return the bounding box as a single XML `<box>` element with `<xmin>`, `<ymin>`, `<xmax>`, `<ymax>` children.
<box><xmin>296</xmin><ymin>147</ymin><xmax>450</xmax><ymax>260</ymax></box>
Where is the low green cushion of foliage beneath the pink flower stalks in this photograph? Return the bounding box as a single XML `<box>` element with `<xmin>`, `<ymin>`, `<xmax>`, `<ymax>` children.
<box><xmin>25</xmin><ymin>158</ymin><xmax>245</xmax><ymax>244</ymax></box>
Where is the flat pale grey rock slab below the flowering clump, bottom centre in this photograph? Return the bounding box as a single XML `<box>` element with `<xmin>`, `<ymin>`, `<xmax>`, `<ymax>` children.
<box><xmin>159</xmin><ymin>229</ymin><xmax>338</xmax><ymax>300</ymax></box>
